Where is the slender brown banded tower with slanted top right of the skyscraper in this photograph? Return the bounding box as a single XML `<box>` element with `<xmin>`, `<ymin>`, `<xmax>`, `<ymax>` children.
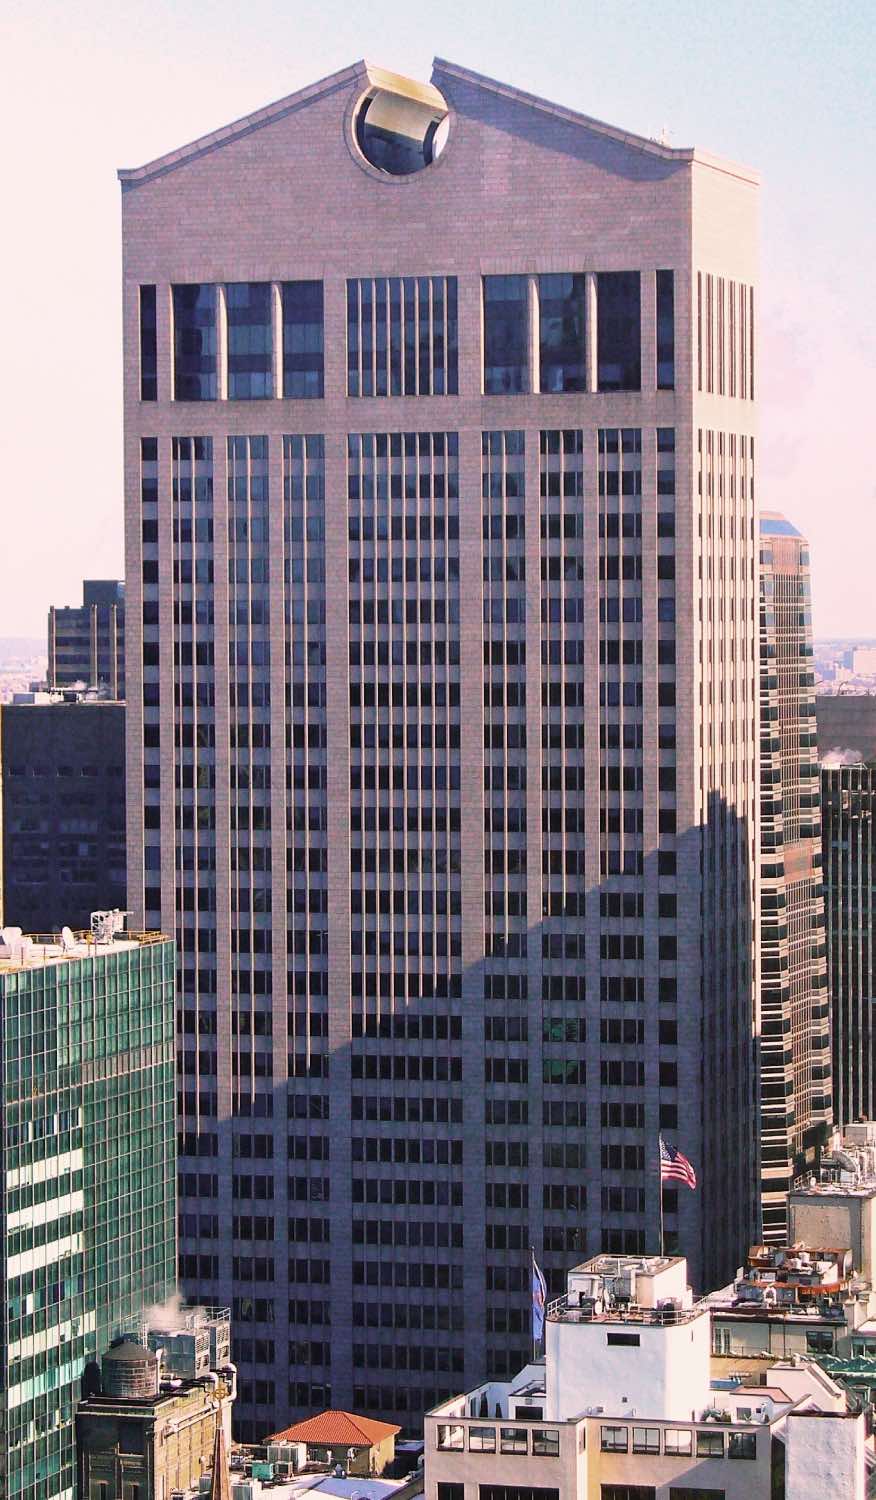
<box><xmin>761</xmin><ymin>510</ymin><xmax>831</xmax><ymax>1245</ymax></box>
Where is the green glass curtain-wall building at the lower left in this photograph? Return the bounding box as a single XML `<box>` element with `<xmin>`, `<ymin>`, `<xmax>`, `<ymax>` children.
<box><xmin>0</xmin><ymin>935</ymin><xmax>176</xmax><ymax>1500</ymax></box>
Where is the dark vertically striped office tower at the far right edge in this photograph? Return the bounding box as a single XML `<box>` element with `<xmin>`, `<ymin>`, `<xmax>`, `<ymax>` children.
<box><xmin>822</xmin><ymin>758</ymin><xmax>876</xmax><ymax>1128</ymax></box>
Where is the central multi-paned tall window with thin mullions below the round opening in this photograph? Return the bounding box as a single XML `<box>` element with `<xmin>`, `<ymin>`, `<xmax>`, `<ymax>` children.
<box><xmin>347</xmin><ymin>276</ymin><xmax>458</xmax><ymax>396</ymax></box>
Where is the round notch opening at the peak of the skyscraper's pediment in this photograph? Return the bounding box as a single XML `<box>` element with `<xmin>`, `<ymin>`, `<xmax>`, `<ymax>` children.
<box><xmin>353</xmin><ymin>68</ymin><xmax>449</xmax><ymax>177</ymax></box>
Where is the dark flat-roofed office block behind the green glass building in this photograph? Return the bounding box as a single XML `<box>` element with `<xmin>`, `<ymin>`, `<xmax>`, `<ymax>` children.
<box><xmin>0</xmin><ymin>695</ymin><xmax>126</xmax><ymax>933</ymax></box>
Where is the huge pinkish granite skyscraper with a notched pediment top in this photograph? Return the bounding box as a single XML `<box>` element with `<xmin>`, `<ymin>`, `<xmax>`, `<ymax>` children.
<box><xmin>120</xmin><ymin>62</ymin><xmax>759</xmax><ymax>1437</ymax></box>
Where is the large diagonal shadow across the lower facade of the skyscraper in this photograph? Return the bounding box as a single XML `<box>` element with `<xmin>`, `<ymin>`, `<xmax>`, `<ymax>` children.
<box><xmin>180</xmin><ymin>795</ymin><xmax>758</xmax><ymax>1440</ymax></box>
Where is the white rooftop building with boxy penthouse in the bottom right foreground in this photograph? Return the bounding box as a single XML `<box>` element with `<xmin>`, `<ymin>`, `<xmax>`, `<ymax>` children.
<box><xmin>425</xmin><ymin>1256</ymin><xmax>869</xmax><ymax>1500</ymax></box>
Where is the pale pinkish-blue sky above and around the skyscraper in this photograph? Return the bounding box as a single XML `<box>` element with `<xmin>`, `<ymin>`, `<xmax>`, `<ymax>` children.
<box><xmin>0</xmin><ymin>0</ymin><xmax>876</xmax><ymax>636</ymax></box>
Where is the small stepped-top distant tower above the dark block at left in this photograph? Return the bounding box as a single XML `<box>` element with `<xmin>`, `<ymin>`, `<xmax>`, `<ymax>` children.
<box><xmin>47</xmin><ymin>578</ymin><xmax>125</xmax><ymax>699</ymax></box>
